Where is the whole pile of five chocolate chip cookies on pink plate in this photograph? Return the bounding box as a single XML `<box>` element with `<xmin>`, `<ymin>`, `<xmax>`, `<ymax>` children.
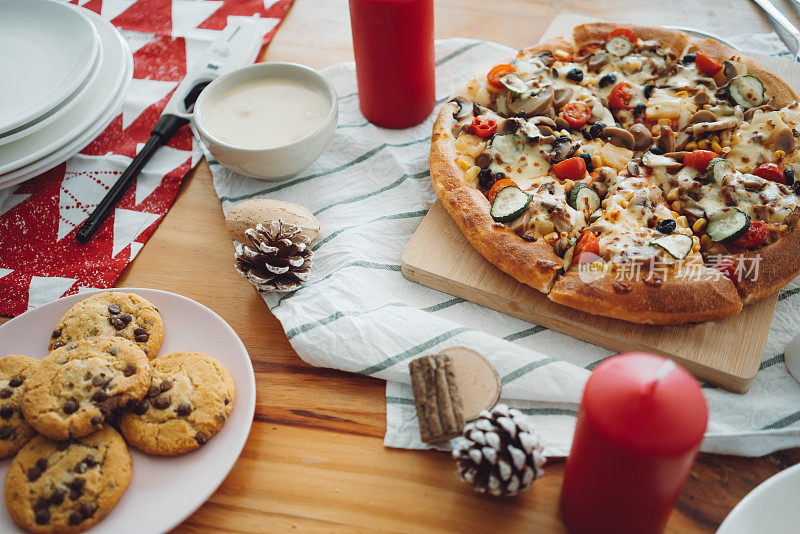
<box><xmin>0</xmin><ymin>292</ymin><xmax>234</xmax><ymax>533</ymax></box>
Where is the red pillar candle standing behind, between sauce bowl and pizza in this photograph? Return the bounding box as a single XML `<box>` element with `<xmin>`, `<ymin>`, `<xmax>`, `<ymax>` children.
<box><xmin>350</xmin><ymin>0</ymin><xmax>436</xmax><ymax>128</ymax></box>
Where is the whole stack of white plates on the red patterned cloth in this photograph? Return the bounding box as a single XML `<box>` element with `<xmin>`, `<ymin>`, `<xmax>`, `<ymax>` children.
<box><xmin>0</xmin><ymin>0</ymin><xmax>133</xmax><ymax>189</ymax></box>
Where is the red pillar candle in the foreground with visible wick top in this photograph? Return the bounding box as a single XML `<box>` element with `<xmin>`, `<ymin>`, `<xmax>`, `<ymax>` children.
<box><xmin>561</xmin><ymin>353</ymin><xmax>708</xmax><ymax>534</ymax></box>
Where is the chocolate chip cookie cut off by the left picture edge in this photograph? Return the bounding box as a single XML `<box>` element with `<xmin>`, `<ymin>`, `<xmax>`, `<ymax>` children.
<box><xmin>0</xmin><ymin>354</ymin><xmax>39</xmax><ymax>458</ymax></box>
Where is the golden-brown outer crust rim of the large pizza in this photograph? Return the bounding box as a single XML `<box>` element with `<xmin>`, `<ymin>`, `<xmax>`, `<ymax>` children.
<box><xmin>429</xmin><ymin>22</ymin><xmax>800</xmax><ymax>324</ymax></box>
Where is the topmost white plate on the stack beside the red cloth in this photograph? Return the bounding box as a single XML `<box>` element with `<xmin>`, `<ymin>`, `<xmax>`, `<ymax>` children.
<box><xmin>0</xmin><ymin>0</ymin><xmax>100</xmax><ymax>133</ymax></box>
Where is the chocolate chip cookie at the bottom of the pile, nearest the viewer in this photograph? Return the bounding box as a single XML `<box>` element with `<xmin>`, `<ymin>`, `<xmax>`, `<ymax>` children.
<box><xmin>5</xmin><ymin>427</ymin><xmax>131</xmax><ymax>533</ymax></box>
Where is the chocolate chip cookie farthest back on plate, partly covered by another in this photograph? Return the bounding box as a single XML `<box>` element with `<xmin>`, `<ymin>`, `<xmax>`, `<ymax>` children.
<box><xmin>48</xmin><ymin>291</ymin><xmax>164</xmax><ymax>358</ymax></box>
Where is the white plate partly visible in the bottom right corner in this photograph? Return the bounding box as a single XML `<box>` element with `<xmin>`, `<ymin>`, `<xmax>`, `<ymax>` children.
<box><xmin>717</xmin><ymin>465</ymin><xmax>800</xmax><ymax>534</ymax></box>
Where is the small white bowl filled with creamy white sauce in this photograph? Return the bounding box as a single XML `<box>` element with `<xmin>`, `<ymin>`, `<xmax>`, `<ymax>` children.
<box><xmin>193</xmin><ymin>63</ymin><xmax>338</xmax><ymax>181</ymax></box>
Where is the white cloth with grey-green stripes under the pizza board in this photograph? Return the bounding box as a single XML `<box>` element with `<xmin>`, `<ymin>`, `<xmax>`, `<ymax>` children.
<box><xmin>211</xmin><ymin>39</ymin><xmax>800</xmax><ymax>456</ymax></box>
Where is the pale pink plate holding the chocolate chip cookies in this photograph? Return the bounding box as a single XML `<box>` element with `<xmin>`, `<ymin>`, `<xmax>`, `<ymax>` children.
<box><xmin>0</xmin><ymin>288</ymin><xmax>256</xmax><ymax>534</ymax></box>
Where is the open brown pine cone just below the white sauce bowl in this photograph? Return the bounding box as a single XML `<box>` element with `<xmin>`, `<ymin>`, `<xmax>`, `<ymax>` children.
<box><xmin>234</xmin><ymin>219</ymin><xmax>314</xmax><ymax>291</ymax></box>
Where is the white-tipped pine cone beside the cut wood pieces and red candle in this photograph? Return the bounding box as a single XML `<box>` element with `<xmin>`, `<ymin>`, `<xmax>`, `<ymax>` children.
<box><xmin>453</xmin><ymin>404</ymin><xmax>545</xmax><ymax>496</ymax></box>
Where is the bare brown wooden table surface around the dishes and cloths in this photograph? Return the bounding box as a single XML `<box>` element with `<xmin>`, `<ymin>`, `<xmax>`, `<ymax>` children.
<box><xmin>9</xmin><ymin>0</ymin><xmax>800</xmax><ymax>533</ymax></box>
